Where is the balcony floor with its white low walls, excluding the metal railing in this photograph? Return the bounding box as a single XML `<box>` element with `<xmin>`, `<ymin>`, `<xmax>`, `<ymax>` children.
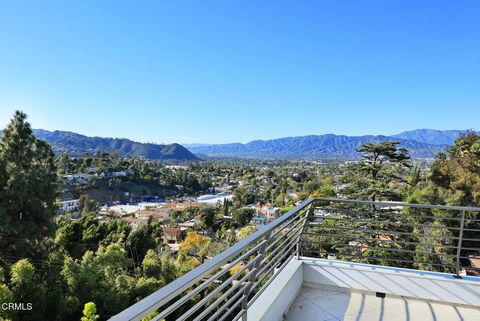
<box><xmin>247</xmin><ymin>257</ymin><xmax>480</xmax><ymax>321</ymax></box>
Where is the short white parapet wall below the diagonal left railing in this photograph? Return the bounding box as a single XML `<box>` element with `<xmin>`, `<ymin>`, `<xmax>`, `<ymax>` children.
<box><xmin>247</xmin><ymin>258</ymin><xmax>303</xmax><ymax>321</ymax></box>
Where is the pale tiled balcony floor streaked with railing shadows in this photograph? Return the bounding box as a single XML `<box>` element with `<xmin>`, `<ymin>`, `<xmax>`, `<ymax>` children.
<box><xmin>285</xmin><ymin>287</ymin><xmax>480</xmax><ymax>321</ymax></box>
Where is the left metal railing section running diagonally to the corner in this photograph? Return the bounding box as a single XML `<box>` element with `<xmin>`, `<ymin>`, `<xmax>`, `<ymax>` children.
<box><xmin>110</xmin><ymin>199</ymin><xmax>314</xmax><ymax>321</ymax></box>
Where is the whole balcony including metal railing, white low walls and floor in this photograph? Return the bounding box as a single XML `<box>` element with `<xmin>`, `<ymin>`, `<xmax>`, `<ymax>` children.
<box><xmin>111</xmin><ymin>199</ymin><xmax>480</xmax><ymax>321</ymax></box>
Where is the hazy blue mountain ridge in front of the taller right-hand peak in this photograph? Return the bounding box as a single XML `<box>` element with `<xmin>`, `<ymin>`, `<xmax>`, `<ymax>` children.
<box><xmin>189</xmin><ymin>134</ymin><xmax>446</xmax><ymax>159</ymax></box>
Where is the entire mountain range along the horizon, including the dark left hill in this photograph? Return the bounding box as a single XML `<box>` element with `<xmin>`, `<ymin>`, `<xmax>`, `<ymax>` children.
<box><xmin>0</xmin><ymin>129</ymin><xmax>479</xmax><ymax>161</ymax></box>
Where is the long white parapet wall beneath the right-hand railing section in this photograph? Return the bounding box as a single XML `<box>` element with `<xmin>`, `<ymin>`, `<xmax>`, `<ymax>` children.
<box><xmin>302</xmin><ymin>257</ymin><xmax>480</xmax><ymax>306</ymax></box>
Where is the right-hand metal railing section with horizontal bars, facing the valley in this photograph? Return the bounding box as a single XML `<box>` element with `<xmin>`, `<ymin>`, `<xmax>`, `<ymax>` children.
<box><xmin>300</xmin><ymin>199</ymin><xmax>480</xmax><ymax>277</ymax></box>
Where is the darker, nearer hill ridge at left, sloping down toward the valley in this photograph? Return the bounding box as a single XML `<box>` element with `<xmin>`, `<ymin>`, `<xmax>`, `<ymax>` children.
<box><xmin>0</xmin><ymin>129</ymin><xmax>199</xmax><ymax>161</ymax></box>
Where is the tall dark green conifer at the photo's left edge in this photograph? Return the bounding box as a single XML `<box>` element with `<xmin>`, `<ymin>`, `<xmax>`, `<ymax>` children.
<box><xmin>0</xmin><ymin>111</ymin><xmax>56</xmax><ymax>257</ymax></box>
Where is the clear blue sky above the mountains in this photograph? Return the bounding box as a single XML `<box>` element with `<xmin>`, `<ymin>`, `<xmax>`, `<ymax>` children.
<box><xmin>0</xmin><ymin>0</ymin><xmax>480</xmax><ymax>143</ymax></box>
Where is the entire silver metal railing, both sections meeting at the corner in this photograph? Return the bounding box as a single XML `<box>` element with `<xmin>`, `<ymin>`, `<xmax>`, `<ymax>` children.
<box><xmin>110</xmin><ymin>199</ymin><xmax>480</xmax><ymax>321</ymax></box>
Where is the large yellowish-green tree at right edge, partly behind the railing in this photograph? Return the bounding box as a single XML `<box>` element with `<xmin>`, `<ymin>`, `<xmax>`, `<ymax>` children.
<box><xmin>406</xmin><ymin>132</ymin><xmax>480</xmax><ymax>270</ymax></box>
